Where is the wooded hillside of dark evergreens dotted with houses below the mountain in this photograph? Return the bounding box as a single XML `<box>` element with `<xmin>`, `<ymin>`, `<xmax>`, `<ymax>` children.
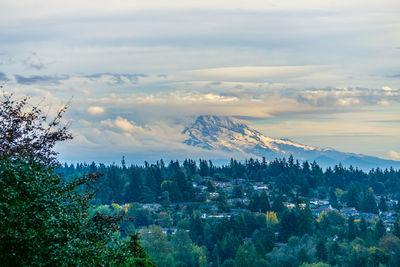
<box><xmin>57</xmin><ymin>156</ymin><xmax>400</xmax><ymax>266</ymax></box>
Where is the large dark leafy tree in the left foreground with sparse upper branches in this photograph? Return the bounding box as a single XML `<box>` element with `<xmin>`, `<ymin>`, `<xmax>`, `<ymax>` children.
<box><xmin>0</xmin><ymin>95</ymin><xmax>153</xmax><ymax>266</ymax></box>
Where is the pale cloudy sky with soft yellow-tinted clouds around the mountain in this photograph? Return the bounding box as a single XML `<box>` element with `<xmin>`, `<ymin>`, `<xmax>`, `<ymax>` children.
<box><xmin>0</xmin><ymin>0</ymin><xmax>400</xmax><ymax>162</ymax></box>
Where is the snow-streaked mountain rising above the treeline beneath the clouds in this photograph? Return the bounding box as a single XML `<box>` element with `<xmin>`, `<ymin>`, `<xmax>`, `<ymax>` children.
<box><xmin>182</xmin><ymin>115</ymin><xmax>400</xmax><ymax>169</ymax></box>
